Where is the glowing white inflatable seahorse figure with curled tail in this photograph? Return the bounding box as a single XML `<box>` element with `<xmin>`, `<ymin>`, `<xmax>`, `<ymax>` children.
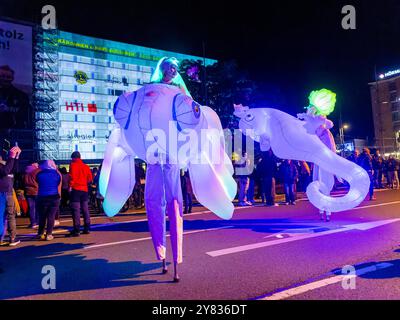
<box><xmin>234</xmin><ymin>95</ymin><xmax>370</xmax><ymax>213</ymax></box>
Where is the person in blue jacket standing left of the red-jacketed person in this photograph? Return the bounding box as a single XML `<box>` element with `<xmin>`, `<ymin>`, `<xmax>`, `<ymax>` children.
<box><xmin>35</xmin><ymin>160</ymin><xmax>62</xmax><ymax>241</ymax></box>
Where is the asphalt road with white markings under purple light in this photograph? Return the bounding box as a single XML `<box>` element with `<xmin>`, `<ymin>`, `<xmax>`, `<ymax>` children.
<box><xmin>0</xmin><ymin>190</ymin><xmax>400</xmax><ymax>300</ymax></box>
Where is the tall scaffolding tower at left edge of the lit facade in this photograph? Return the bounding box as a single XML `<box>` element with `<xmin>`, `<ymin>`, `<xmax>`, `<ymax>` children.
<box><xmin>33</xmin><ymin>26</ymin><xmax>59</xmax><ymax>160</ymax></box>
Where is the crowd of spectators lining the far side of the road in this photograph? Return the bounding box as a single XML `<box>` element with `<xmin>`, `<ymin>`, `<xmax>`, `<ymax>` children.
<box><xmin>0</xmin><ymin>147</ymin><xmax>400</xmax><ymax>250</ymax></box>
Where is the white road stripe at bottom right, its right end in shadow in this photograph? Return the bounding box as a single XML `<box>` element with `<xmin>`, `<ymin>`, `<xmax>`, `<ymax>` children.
<box><xmin>257</xmin><ymin>262</ymin><xmax>393</xmax><ymax>300</ymax></box>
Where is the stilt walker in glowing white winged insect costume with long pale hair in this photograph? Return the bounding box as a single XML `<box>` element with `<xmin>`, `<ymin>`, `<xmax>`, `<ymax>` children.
<box><xmin>99</xmin><ymin>58</ymin><xmax>236</xmax><ymax>282</ymax></box>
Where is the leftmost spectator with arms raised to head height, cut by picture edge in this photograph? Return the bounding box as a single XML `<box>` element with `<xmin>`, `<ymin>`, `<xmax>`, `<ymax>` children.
<box><xmin>0</xmin><ymin>147</ymin><xmax>21</xmax><ymax>246</ymax></box>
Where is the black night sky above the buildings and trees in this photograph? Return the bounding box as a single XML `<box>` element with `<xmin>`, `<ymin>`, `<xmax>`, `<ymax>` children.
<box><xmin>0</xmin><ymin>0</ymin><xmax>400</xmax><ymax>138</ymax></box>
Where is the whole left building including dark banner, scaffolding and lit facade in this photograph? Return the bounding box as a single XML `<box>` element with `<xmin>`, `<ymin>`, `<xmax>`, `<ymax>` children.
<box><xmin>0</xmin><ymin>17</ymin><xmax>217</xmax><ymax>163</ymax></box>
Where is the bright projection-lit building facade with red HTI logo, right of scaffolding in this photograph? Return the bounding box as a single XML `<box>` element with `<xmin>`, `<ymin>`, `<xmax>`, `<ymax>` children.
<box><xmin>43</xmin><ymin>31</ymin><xmax>216</xmax><ymax>160</ymax></box>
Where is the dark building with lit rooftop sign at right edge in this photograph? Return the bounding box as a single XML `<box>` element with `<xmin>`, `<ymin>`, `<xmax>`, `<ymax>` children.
<box><xmin>369</xmin><ymin>70</ymin><xmax>400</xmax><ymax>154</ymax></box>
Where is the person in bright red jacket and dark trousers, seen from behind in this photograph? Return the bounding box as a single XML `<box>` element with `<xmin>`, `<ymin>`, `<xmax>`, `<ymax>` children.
<box><xmin>69</xmin><ymin>151</ymin><xmax>93</xmax><ymax>237</ymax></box>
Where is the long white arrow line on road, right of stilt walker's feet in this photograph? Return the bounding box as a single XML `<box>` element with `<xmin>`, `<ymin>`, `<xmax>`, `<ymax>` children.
<box><xmin>206</xmin><ymin>219</ymin><xmax>400</xmax><ymax>257</ymax></box>
